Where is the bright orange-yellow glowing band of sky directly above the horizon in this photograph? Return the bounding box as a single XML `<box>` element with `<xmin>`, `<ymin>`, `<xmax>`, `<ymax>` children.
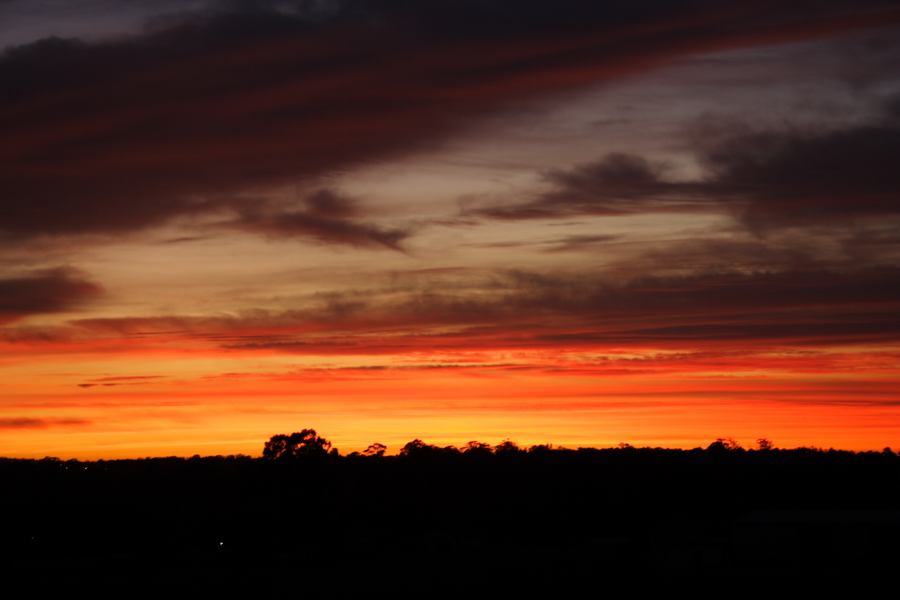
<box><xmin>7</xmin><ymin>342</ymin><xmax>900</xmax><ymax>459</ymax></box>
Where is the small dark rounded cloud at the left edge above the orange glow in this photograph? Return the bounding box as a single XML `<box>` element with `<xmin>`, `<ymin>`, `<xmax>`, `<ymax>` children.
<box><xmin>0</xmin><ymin>267</ymin><xmax>102</xmax><ymax>323</ymax></box>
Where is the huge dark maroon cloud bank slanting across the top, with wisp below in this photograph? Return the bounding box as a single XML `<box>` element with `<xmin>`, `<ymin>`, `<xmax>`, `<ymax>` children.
<box><xmin>0</xmin><ymin>0</ymin><xmax>900</xmax><ymax>247</ymax></box>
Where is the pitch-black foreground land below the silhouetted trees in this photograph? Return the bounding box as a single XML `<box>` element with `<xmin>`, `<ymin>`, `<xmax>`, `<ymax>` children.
<box><xmin>0</xmin><ymin>448</ymin><xmax>900</xmax><ymax>597</ymax></box>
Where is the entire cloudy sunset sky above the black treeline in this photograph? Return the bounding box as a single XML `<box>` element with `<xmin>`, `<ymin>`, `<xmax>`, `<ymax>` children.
<box><xmin>0</xmin><ymin>0</ymin><xmax>900</xmax><ymax>458</ymax></box>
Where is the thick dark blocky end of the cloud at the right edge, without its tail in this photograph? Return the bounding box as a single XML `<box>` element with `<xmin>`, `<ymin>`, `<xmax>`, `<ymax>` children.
<box><xmin>701</xmin><ymin>108</ymin><xmax>900</xmax><ymax>230</ymax></box>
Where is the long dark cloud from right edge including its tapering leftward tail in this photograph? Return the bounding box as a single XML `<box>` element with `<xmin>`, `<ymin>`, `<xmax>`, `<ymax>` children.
<box><xmin>482</xmin><ymin>98</ymin><xmax>900</xmax><ymax>231</ymax></box>
